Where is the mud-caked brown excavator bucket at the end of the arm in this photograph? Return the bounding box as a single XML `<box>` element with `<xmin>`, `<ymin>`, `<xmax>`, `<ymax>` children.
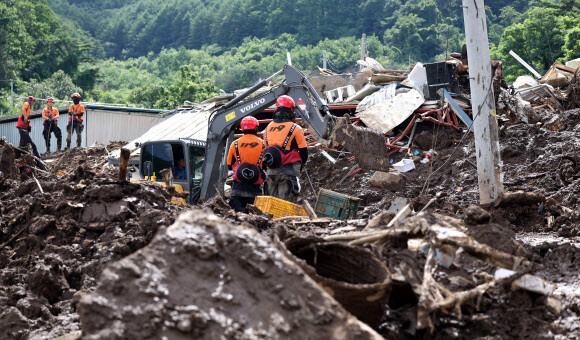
<box><xmin>329</xmin><ymin>120</ymin><xmax>390</xmax><ymax>171</ymax></box>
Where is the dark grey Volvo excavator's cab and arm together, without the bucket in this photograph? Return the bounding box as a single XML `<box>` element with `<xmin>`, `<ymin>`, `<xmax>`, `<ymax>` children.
<box><xmin>139</xmin><ymin>65</ymin><xmax>384</xmax><ymax>204</ymax></box>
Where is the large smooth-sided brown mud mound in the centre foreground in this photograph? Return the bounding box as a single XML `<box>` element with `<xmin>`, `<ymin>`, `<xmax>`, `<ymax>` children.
<box><xmin>80</xmin><ymin>211</ymin><xmax>380</xmax><ymax>339</ymax></box>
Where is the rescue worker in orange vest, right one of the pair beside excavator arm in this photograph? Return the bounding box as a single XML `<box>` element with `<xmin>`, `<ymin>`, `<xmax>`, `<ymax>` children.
<box><xmin>264</xmin><ymin>96</ymin><xmax>308</xmax><ymax>202</ymax></box>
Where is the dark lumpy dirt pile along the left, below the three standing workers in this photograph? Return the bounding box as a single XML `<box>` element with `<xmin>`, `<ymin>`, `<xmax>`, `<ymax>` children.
<box><xmin>0</xmin><ymin>144</ymin><xmax>182</xmax><ymax>339</ymax></box>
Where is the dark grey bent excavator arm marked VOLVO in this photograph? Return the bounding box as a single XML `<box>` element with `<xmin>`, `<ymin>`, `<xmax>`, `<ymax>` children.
<box><xmin>200</xmin><ymin>65</ymin><xmax>335</xmax><ymax>200</ymax></box>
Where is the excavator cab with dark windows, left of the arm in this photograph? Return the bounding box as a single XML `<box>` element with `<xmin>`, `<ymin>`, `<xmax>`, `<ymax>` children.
<box><xmin>139</xmin><ymin>138</ymin><xmax>206</xmax><ymax>204</ymax></box>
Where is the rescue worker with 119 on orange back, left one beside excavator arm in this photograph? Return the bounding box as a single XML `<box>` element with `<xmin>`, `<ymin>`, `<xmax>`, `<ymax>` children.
<box><xmin>227</xmin><ymin>117</ymin><xmax>265</xmax><ymax>213</ymax></box>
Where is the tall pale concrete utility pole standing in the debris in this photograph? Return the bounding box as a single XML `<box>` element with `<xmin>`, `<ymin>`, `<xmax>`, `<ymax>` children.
<box><xmin>463</xmin><ymin>0</ymin><xmax>503</xmax><ymax>204</ymax></box>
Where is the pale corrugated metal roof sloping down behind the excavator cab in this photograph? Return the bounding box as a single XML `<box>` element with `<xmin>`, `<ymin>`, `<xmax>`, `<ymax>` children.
<box><xmin>111</xmin><ymin>109</ymin><xmax>212</xmax><ymax>158</ymax></box>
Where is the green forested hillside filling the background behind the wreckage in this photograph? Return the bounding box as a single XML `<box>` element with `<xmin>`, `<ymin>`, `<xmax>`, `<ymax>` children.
<box><xmin>0</xmin><ymin>0</ymin><xmax>580</xmax><ymax>112</ymax></box>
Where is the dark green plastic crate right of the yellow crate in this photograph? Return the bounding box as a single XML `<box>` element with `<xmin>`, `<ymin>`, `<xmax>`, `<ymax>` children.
<box><xmin>314</xmin><ymin>189</ymin><xmax>360</xmax><ymax>220</ymax></box>
